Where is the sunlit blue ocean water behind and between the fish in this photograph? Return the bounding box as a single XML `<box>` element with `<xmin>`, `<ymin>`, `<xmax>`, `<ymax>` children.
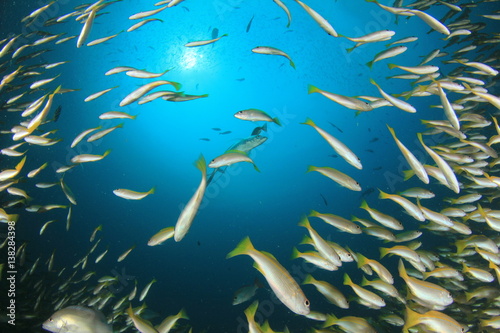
<box><xmin>0</xmin><ymin>0</ymin><xmax>498</xmax><ymax>332</ymax></box>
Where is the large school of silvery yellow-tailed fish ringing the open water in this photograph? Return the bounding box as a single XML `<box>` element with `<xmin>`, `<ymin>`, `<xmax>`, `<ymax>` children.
<box><xmin>0</xmin><ymin>0</ymin><xmax>500</xmax><ymax>333</ymax></box>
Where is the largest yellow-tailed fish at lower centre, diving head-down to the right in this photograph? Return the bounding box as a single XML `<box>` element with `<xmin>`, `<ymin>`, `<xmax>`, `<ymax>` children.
<box><xmin>226</xmin><ymin>237</ymin><xmax>310</xmax><ymax>315</ymax></box>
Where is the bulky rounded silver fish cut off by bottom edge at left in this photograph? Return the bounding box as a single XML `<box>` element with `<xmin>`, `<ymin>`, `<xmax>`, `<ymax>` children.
<box><xmin>42</xmin><ymin>305</ymin><xmax>113</xmax><ymax>333</ymax></box>
